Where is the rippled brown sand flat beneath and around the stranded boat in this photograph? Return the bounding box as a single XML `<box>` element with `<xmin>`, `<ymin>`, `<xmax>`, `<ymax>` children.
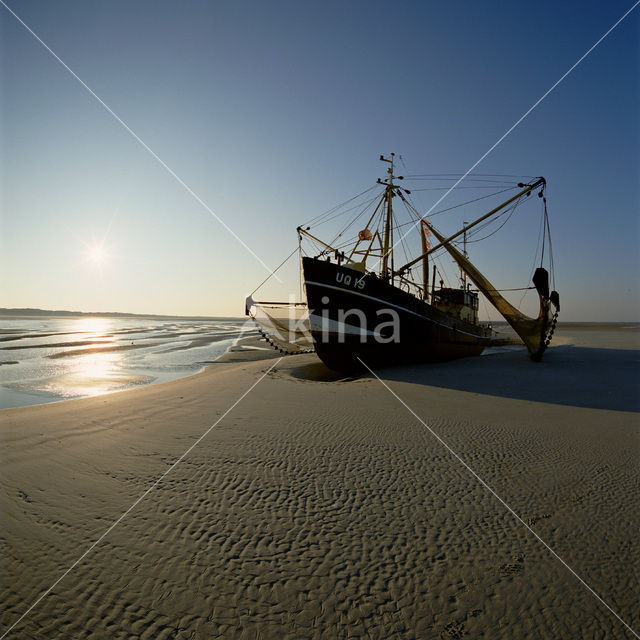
<box><xmin>0</xmin><ymin>325</ymin><xmax>640</xmax><ymax>640</ymax></box>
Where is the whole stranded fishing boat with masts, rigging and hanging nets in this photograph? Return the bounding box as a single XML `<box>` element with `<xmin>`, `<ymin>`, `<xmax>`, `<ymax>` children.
<box><xmin>246</xmin><ymin>154</ymin><xmax>560</xmax><ymax>371</ymax></box>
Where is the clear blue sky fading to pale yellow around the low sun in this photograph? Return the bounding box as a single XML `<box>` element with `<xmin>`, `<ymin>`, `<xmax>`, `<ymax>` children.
<box><xmin>0</xmin><ymin>0</ymin><xmax>640</xmax><ymax>321</ymax></box>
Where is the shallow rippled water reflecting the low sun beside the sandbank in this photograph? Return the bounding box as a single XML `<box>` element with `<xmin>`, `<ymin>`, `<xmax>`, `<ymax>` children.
<box><xmin>0</xmin><ymin>316</ymin><xmax>255</xmax><ymax>408</ymax></box>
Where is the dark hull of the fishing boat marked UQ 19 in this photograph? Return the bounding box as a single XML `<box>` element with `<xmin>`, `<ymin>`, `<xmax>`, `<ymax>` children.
<box><xmin>302</xmin><ymin>258</ymin><xmax>491</xmax><ymax>372</ymax></box>
